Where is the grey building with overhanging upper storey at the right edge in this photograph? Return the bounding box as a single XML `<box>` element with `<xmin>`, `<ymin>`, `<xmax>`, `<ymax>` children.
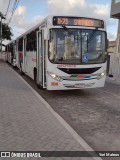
<box><xmin>110</xmin><ymin>0</ymin><xmax>120</xmax><ymax>77</ymax></box>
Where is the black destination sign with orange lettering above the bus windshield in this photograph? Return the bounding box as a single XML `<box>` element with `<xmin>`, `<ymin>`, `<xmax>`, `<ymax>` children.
<box><xmin>53</xmin><ymin>16</ymin><xmax>104</xmax><ymax>28</ymax></box>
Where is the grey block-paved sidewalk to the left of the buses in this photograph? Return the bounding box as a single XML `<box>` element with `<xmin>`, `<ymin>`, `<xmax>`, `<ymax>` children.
<box><xmin>0</xmin><ymin>62</ymin><xmax>100</xmax><ymax>160</ymax></box>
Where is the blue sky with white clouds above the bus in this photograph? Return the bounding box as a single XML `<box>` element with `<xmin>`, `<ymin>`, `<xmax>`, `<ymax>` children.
<box><xmin>0</xmin><ymin>0</ymin><xmax>118</xmax><ymax>40</ymax></box>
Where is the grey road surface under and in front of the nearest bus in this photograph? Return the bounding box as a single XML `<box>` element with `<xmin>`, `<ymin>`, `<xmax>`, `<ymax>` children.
<box><xmin>13</xmin><ymin>65</ymin><xmax>120</xmax><ymax>160</ymax></box>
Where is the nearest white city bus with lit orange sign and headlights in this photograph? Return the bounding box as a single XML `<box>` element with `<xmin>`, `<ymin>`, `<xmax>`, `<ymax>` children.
<box><xmin>5</xmin><ymin>16</ymin><xmax>107</xmax><ymax>90</ymax></box>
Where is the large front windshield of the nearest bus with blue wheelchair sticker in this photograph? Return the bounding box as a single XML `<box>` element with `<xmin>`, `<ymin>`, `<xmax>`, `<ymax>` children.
<box><xmin>49</xmin><ymin>28</ymin><xmax>106</xmax><ymax>64</ymax></box>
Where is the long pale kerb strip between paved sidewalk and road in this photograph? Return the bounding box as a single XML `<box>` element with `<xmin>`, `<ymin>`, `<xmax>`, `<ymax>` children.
<box><xmin>11</xmin><ymin>69</ymin><xmax>102</xmax><ymax>160</ymax></box>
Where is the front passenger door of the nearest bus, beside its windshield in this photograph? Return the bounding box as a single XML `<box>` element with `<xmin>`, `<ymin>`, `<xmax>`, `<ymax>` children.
<box><xmin>37</xmin><ymin>30</ymin><xmax>46</xmax><ymax>88</ymax></box>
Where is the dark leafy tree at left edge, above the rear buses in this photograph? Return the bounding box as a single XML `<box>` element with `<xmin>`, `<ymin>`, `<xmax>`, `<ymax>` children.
<box><xmin>0</xmin><ymin>22</ymin><xmax>13</xmax><ymax>40</ymax></box>
